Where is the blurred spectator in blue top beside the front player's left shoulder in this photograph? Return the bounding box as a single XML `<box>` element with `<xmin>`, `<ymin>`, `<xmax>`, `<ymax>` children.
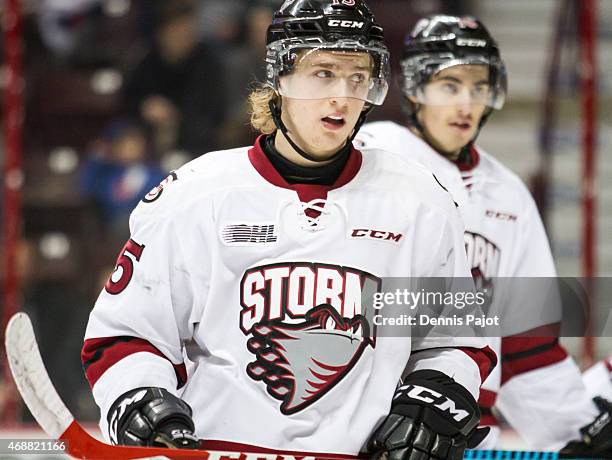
<box><xmin>81</xmin><ymin>120</ymin><xmax>167</xmax><ymax>239</ymax></box>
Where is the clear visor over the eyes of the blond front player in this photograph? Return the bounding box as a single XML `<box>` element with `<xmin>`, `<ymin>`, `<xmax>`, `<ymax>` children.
<box><xmin>277</xmin><ymin>44</ymin><xmax>389</xmax><ymax>105</ymax></box>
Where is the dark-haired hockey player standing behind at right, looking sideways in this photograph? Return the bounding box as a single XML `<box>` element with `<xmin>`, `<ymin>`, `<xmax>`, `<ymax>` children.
<box><xmin>356</xmin><ymin>15</ymin><xmax>612</xmax><ymax>455</ymax></box>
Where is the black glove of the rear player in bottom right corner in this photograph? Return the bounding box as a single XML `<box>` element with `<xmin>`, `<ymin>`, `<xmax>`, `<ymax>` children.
<box><xmin>559</xmin><ymin>397</ymin><xmax>612</xmax><ymax>458</ymax></box>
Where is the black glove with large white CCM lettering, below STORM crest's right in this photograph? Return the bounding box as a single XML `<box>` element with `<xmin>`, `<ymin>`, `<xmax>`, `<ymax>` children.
<box><xmin>368</xmin><ymin>370</ymin><xmax>489</xmax><ymax>460</ymax></box>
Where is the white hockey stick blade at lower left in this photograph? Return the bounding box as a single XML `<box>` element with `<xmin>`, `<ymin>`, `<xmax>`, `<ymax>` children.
<box><xmin>5</xmin><ymin>313</ymin><xmax>74</xmax><ymax>439</ymax></box>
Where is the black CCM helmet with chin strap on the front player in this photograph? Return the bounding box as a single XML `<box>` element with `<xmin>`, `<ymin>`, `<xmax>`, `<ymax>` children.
<box><xmin>266</xmin><ymin>0</ymin><xmax>390</xmax><ymax>161</ymax></box>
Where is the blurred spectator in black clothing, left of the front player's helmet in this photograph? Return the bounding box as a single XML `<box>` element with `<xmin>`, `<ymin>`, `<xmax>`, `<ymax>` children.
<box><xmin>124</xmin><ymin>0</ymin><xmax>226</xmax><ymax>156</ymax></box>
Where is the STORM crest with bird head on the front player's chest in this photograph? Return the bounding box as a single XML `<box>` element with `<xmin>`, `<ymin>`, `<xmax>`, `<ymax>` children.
<box><xmin>240</xmin><ymin>263</ymin><xmax>382</xmax><ymax>415</ymax></box>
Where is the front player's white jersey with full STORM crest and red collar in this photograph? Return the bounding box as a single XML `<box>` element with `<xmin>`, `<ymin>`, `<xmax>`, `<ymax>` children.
<box><xmin>83</xmin><ymin>136</ymin><xmax>490</xmax><ymax>454</ymax></box>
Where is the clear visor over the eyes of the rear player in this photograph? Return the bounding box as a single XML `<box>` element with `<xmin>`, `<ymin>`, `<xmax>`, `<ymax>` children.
<box><xmin>412</xmin><ymin>59</ymin><xmax>506</xmax><ymax>110</ymax></box>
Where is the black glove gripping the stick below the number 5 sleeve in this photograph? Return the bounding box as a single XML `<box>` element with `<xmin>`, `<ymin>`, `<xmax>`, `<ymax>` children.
<box><xmin>108</xmin><ymin>387</ymin><xmax>199</xmax><ymax>449</ymax></box>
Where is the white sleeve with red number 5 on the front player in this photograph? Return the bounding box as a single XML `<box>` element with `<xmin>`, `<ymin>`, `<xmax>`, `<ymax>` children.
<box><xmin>82</xmin><ymin>188</ymin><xmax>208</xmax><ymax>434</ymax></box>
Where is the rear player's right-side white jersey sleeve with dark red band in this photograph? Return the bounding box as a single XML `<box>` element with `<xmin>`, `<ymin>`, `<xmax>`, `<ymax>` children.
<box><xmin>496</xmin><ymin>192</ymin><xmax>597</xmax><ymax>449</ymax></box>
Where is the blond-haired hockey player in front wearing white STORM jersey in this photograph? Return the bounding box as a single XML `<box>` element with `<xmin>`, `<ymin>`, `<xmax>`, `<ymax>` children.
<box><xmin>82</xmin><ymin>0</ymin><xmax>496</xmax><ymax>459</ymax></box>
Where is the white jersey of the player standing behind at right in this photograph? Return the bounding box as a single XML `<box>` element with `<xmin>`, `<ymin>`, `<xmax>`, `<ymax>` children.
<box><xmin>355</xmin><ymin>122</ymin><xmax>597</xmax><ymax>449</ymax></box>
